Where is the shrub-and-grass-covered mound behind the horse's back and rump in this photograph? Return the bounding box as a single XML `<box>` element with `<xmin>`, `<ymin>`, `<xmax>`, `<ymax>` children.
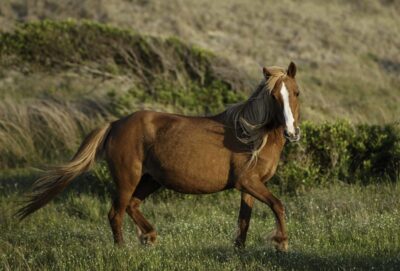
<box><xmin>0</xmin><ymin>21</ymin><xmax>249</xmax><ymax>168</ymax></box>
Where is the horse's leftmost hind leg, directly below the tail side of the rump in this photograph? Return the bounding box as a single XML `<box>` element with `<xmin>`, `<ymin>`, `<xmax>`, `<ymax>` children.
<box><xmin>108</xmin><ymin>162</ymin><xmax>141</xmax><ymax>245</ymax></box>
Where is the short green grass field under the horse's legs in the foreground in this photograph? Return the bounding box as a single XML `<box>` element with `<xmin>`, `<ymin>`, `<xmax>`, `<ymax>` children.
<box><xmin>0</xmin><ymin>171</ymin><xmax>400</xmax><ymax>270</ymax></box>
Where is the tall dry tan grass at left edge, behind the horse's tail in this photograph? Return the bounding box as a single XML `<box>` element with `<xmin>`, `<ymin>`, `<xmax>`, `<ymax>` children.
<box><xmin>0</xmin><ymin>99</ymin><xmax>107</xmax><ymax>168</ymax></box>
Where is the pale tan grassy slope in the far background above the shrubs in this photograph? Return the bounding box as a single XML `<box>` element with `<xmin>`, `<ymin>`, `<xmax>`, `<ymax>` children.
<box><xmin>0</xmin><ymin>0</ymin><xmax>400</xmax><ymax>123</ymax></box>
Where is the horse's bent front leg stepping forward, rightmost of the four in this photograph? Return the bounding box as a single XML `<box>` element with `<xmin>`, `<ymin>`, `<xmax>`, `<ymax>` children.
<box><xmin>238</xmin><ymin>179</ymin><xmax>288</xmax><ymax>251</ymax></box>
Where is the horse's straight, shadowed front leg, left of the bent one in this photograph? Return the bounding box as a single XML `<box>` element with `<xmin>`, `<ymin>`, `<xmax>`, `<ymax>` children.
<box><xmin>235</xmin><ymin>192</ymin><xmax>254</xmax><ymax>248</ymax></box>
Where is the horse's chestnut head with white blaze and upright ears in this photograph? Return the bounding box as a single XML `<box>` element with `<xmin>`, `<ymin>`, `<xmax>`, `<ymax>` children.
<box><xmin>263</xmin><ymin>62</ymin><xmax>300</xmax><ymax>142</ymax></box>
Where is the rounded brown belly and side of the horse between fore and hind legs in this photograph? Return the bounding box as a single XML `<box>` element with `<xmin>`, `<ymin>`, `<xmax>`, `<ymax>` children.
<box><xmin>148</xmin><ymin>119</ymin><xmax>231</xmax><ymax>194</ymax></box>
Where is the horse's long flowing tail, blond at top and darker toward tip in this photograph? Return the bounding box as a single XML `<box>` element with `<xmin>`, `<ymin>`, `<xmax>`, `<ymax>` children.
<box><xmin>16</xmin><ymin>123</ymin><xmax>111</xmax><ymax>220</ymax></box>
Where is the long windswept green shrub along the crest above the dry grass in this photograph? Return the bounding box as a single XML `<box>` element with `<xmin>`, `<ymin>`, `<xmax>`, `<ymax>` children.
<box><xmin>0</xmin><ymin>20</ymin><xmax>249</xmax><ymax>93</ymax></box>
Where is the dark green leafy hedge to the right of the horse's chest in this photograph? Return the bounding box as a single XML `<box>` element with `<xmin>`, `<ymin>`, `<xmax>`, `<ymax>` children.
<box><xmin>273</xmin><ymin>122</ymin><xmax>400</xmax><ymax>193</ymax></box>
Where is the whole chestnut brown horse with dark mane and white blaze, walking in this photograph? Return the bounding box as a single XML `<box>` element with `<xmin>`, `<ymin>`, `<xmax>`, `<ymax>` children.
<box><xmin>17</xmin><ymin>63</ymin><xmax>300</xmax><ymax>251</ymax></box>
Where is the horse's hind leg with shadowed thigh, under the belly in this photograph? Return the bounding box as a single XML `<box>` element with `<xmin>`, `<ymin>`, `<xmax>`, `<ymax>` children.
<box><xmin>126</xmin><ymin>174</ymin><xmax>161</xmax><ymax>244</ymax></box>
